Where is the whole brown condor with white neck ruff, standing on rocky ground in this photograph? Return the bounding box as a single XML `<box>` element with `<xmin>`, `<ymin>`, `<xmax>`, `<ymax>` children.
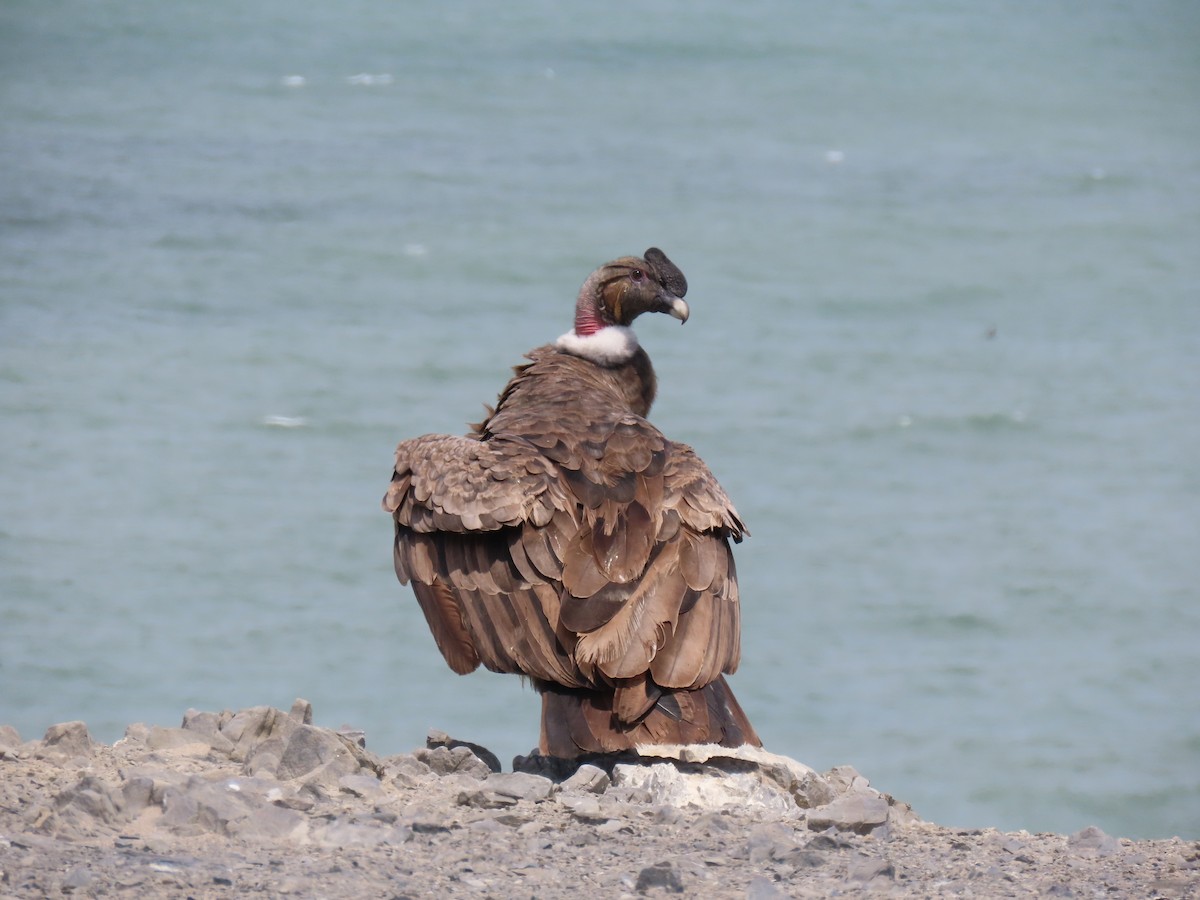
<box><xmin>383</xmin><ymin>247</ymin><xmax>760</xmax><ymax>758</ymax></box>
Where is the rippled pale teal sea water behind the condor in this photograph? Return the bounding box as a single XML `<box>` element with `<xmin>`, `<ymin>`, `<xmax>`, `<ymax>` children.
<box><xmin>0</xmin><ymin>0</ymin><xmax>1200</xmax><ymax>838</ymax></box>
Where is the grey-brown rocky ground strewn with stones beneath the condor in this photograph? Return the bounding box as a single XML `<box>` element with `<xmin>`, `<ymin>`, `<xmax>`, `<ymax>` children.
<box><xmin>0</xmin><ymin>701</ymin><xmax>1200</xmax><ymax>900</ymax></box>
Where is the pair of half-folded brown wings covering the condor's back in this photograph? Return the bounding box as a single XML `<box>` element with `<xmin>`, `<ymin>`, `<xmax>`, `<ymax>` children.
<box><xmin>384</xmin><ymin>413</ymin><xmax>745</xmax><ymax>721</ymax></box>
